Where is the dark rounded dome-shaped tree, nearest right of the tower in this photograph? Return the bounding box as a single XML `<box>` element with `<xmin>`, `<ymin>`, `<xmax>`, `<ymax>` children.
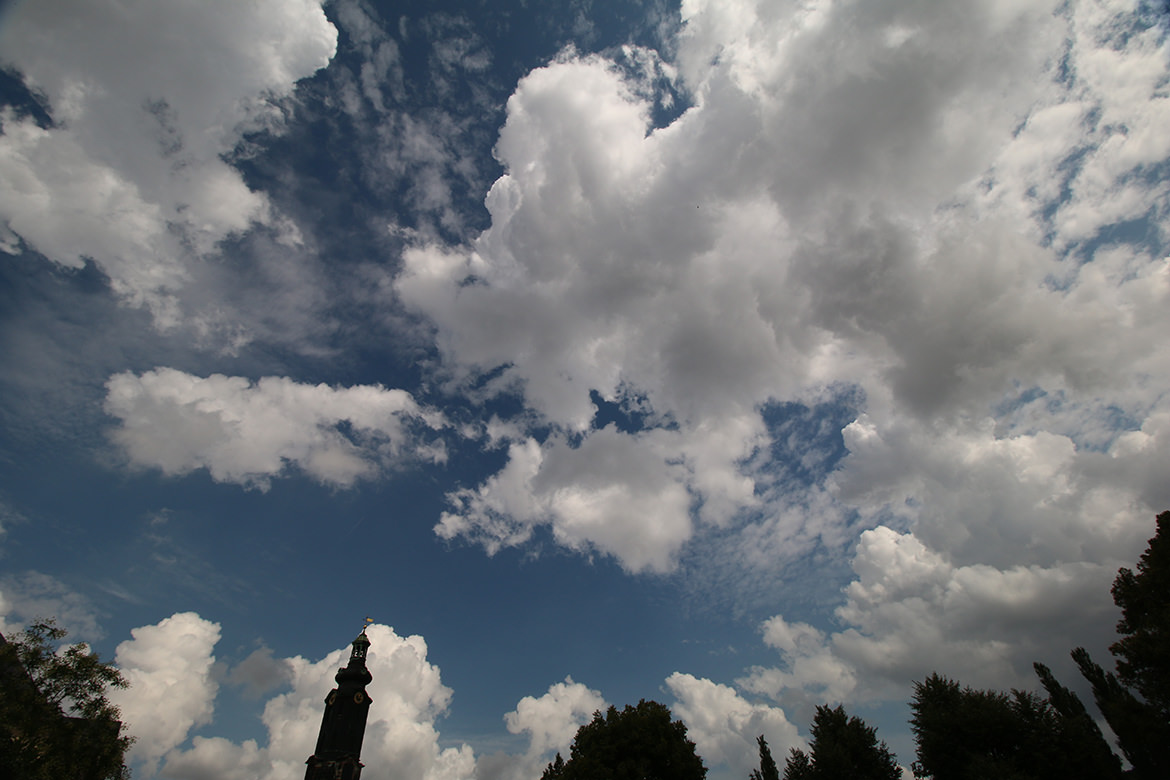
<box><xmin>541</xmin><ymin>699</ymin><xmax>707</xmax><ymax>780</ymax></box>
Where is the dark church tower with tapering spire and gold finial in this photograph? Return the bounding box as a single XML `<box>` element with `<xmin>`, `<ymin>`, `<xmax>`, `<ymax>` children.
<box><xmin>304</xmin><ymin>630</ymin><xmax>373</xmax><ymax>780</ymax></box>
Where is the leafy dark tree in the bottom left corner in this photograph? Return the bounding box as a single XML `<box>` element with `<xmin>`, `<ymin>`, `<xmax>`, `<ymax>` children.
<box><xmin>0</xmin><ymin>620</ymin><xmax>132</xmax><ymax>780</ymax></box>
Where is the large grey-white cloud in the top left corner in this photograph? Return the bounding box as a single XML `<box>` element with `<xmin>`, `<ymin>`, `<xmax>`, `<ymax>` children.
<box><xmin>0</xmin><ymin>0</ymin><xmax>337</xmax><ymax>326</ymax></box>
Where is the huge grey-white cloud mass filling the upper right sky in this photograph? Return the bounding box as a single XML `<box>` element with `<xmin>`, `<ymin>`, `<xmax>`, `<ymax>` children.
<box><xmin>395</xmin><ymin>0</ymin><xmax>1170</xmax><ymax>603</ymax></box>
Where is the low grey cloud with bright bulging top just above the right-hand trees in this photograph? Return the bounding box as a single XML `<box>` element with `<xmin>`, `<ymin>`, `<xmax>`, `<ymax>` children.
<box><xmin>739</xmin><ymin>526</ymin><xmax>1117</xmax><ymax>710</ymax></box>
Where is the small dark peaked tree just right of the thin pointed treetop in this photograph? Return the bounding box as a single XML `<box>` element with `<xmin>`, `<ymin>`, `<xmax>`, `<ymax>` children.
<box><xmin>784</xmin><ymin>705</ymin><xmax>902</xmax><ymax>780</ymax></box>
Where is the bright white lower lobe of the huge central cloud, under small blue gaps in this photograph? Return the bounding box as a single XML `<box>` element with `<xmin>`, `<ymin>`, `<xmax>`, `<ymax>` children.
<box><xmin>435</xmin><ymin>415</ymin><xmax>758</xmax><ymax>573</ymax></box>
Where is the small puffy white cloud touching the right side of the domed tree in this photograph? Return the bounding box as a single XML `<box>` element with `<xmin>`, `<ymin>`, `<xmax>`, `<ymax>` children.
<box><xmin>666</xmin><ymin>672</ymin><xmax>805</xmax><ymax>776</ymax></box>
